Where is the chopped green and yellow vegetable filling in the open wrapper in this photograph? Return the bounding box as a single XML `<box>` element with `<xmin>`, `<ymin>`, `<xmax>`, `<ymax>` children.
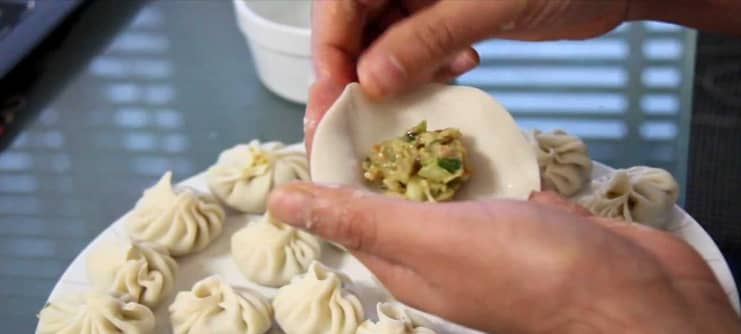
<box><xmin>363</xmin><ymin>121</ymin><xmax>470</xmax><ymax>202</ymax></box>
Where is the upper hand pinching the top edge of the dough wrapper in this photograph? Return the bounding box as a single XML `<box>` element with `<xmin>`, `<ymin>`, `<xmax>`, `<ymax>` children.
<box><xmin>304</xmin><ymin>0</ymin><xmax>628</xmax><ymax>152</ymax></box>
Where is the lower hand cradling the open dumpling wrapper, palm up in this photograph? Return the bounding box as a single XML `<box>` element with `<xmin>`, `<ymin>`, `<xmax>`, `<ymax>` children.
<box><xmin>269</xmin><ymin>183</ymin><xmax>741</xmax><ymax>333</ymax></box>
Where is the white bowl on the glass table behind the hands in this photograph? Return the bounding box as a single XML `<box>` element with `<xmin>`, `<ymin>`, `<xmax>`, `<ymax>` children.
<box><xmin>234</xmin><ymin>0</ymin><xmax>314</xmax><ymax>103</ymax></box>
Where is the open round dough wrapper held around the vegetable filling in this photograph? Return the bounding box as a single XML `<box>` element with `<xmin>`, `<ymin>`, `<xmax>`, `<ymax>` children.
<box><xmin>310</xmin><ymin>83</ymin><xmax>540</xmax><ymax>200</ymax></box>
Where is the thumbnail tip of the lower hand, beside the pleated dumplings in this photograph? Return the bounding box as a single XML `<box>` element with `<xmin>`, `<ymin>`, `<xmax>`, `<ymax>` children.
<box><xmin>269</xmin><ymin>184</ymin><xmax>314</xmax><ymax>227</ymax></box>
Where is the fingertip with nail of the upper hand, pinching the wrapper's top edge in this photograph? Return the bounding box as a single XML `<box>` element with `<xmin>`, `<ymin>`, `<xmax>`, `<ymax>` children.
<box><xmin>358</xmin><ymin>54</ymin><xmax>407</xmax><ymax>97</ymax></box>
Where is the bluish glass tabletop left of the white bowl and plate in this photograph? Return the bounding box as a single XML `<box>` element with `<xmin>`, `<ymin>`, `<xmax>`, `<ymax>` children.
<box><xmin>0</xmin><ymin>0</ymin><xmax>724</xmax><ymax>333</ymax></box>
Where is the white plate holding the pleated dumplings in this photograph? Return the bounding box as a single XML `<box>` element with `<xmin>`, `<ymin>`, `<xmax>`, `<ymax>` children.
<box><xmin>40</xmin><ymin>145</ymin><xmax>739</xmax><ymax>334</ymax></box>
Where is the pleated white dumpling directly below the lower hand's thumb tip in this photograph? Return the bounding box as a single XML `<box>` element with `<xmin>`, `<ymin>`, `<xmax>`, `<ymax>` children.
<box><xmin>231</xmin><ymin>214</ymin><xmax>321</xmax><ymax>287</ymax></box>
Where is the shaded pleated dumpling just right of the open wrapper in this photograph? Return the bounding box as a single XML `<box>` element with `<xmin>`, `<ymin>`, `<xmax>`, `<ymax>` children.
<box><xmin>527</xmin><ymin>130</ymin><xmax>592</xmax><ymax>196</ymax></box>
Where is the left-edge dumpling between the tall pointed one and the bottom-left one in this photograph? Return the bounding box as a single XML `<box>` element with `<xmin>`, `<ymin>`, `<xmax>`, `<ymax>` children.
<box><xmin>87</xmin><ymin>242</ymin><xmax>177</xmax><ymax>307</ymax></box>
